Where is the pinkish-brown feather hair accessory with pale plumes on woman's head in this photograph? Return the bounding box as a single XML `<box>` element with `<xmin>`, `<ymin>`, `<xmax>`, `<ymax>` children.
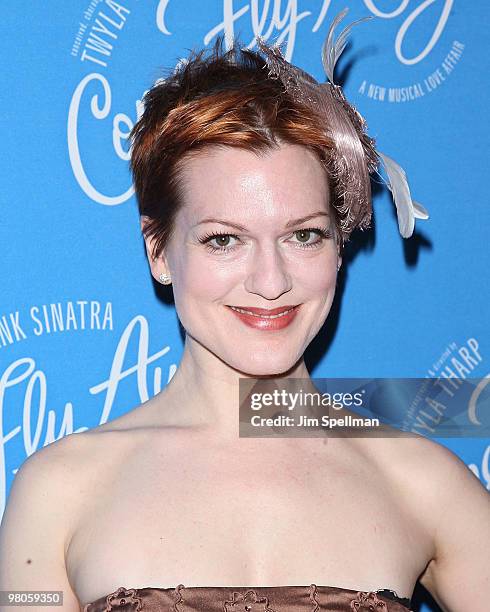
<box><xmin>257</xmin><ymin>8</ymin><xmax>429</xmax><ymax>242</ymax></box>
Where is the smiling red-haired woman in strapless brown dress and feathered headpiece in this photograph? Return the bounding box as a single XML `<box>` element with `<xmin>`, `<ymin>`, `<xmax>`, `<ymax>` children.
<box><xmin>0</xmin><ymin>11</ymin><xmax>490</xmax><ymax>612</ymax></box>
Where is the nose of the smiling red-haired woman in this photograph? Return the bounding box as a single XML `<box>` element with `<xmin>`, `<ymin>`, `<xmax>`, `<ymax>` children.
<box><xmin>245</xmin><ymin>245</ymin><xmax>292</xmax><ymax>300</ymax></box>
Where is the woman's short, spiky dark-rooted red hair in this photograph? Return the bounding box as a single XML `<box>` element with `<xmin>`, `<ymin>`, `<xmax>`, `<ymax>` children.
<box><xmin>131</xmin><ymin>38</ymin><xmax>341</xmax><ymax>257</ymax></box>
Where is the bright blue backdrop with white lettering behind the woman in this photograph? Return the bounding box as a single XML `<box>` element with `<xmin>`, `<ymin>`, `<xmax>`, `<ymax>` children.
<box><xmin>0</xmin><ymin>0</ymin><xmax>490</xmax><ymax>610</ymax></box>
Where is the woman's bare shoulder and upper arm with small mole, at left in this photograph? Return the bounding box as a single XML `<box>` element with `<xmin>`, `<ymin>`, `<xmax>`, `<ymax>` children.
<box><xmin>0</xmin><ymin>418</ymin><xmax>145</xmax><ymax>612</ymax></box>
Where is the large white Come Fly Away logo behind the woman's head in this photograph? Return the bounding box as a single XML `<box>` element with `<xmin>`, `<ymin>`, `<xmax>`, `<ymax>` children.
<box><xmin>67</xmin><ymin>0</ymin><xmax>465</xmax><ymax>206</ymax></box>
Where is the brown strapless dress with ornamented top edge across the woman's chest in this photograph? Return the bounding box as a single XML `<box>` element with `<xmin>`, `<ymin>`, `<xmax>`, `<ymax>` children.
<box><xmin>83</xmin><ymin>584</ymin><xmax>411</xmax><ymax>612</ymax></box>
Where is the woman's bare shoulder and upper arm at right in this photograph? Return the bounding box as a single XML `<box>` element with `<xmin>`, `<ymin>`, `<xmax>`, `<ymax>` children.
<box><xmin>366</xmin><ymin>435</ymin><xmax>490</xmax><ymax>612</ymax></box>
